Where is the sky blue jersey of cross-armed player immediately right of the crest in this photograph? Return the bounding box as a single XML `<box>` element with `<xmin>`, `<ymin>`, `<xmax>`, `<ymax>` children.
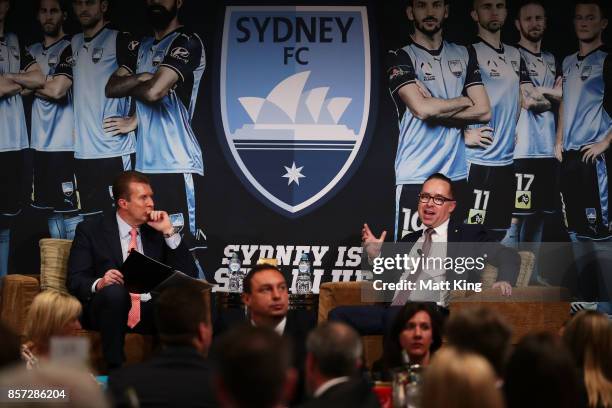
<box><xmin>387</xmin><ymin>41</ymin><xmax>482</xmax><ymax>184</ymax></box>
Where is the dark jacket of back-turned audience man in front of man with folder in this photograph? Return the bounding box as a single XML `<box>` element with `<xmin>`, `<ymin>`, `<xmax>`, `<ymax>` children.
<box><xmin>108</xmin><ymin>347</ymin><xmax>217</xmax><ymax>407</ymax></box>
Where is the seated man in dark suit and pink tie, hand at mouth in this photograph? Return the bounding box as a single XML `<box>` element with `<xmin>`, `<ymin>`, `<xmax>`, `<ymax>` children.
<box><xmin>66</xmin><ymin>171</ymin><xmax>197</xmax><ymax>369</ymax></box>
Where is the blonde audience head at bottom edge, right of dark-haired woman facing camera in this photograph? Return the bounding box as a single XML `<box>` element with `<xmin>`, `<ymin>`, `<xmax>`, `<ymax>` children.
<box><xmin>421</xmin><ymin>347</ymin><xmax>504</xmax><ymax>408</ymax></box>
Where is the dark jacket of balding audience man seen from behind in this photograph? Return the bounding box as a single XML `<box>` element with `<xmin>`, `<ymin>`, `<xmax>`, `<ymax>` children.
<box><xmin>299</xmin><ymin>379</ymin><xmax>380</xmax><ymax>408</ymax></box>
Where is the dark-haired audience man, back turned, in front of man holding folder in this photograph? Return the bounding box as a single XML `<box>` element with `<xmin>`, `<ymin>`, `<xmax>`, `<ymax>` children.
<box><xmin>108</xmin><ymin>285</ymin><xmax>217</xmax><ymax>407</ymax></box>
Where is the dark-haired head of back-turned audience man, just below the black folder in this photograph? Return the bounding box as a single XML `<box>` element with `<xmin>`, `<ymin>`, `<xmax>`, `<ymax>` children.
<box><xmin>155</xmin><ymin>285</ymin><xmax>212</xmax><ymax>354</ymax></box>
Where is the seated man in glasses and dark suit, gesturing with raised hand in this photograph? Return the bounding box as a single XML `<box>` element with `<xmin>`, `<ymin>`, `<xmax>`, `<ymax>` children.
<box><xmin>330</xmin><ymin>173</ymin><xmax>521</xmax><ymax>334</ymax></box>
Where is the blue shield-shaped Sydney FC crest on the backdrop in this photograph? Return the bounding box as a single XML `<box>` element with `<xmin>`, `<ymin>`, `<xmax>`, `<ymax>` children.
<box><xmin>219</xmin><ymin>6</ymin><xmax>371</xmax><ymax>217</ymax></box>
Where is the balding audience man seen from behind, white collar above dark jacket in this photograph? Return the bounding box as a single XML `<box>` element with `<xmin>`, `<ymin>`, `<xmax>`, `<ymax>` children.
<box><xmin>302</xmin><ymin>322</ymin><xmax>380</xmax><ymax>408</ymax></box>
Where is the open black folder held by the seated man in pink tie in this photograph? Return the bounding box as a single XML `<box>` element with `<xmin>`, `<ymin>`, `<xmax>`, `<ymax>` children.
<box><xmin>121</xmin><ymin>250</ymin><xmax>211</xmax><ymax>293</ymax></box>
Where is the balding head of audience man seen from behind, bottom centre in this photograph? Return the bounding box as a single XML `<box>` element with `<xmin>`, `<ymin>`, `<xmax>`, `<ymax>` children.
<box><xmin>306</xmin><ymin>322</ymin><xmax>363</xmax><ymax>392</ymax></box>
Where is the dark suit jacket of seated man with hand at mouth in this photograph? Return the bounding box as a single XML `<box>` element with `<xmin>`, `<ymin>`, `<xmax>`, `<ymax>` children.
<box><xmin>66</xmin><ymin>212</ymin><xmax>197</xmax><ymax>304</ymax></box>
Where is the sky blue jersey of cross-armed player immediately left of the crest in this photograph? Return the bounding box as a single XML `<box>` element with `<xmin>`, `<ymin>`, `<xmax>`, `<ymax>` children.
<box><xmin>124</xmin><ymin>27</ymin><xmax>206</xmax><ymax>175</ymax></box>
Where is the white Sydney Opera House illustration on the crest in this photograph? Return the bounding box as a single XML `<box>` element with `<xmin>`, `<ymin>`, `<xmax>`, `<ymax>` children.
<box><xmin>232</xmin><ymin>71</ymin><xmax>358</xmax><ymax>142</ymax></box>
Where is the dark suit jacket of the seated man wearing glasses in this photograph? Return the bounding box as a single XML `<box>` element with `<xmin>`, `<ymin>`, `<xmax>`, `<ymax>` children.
<box><xmin>400</xmin><ymin>219</ymin><xmax>521</xmax><ymax>285</ymax></box>
